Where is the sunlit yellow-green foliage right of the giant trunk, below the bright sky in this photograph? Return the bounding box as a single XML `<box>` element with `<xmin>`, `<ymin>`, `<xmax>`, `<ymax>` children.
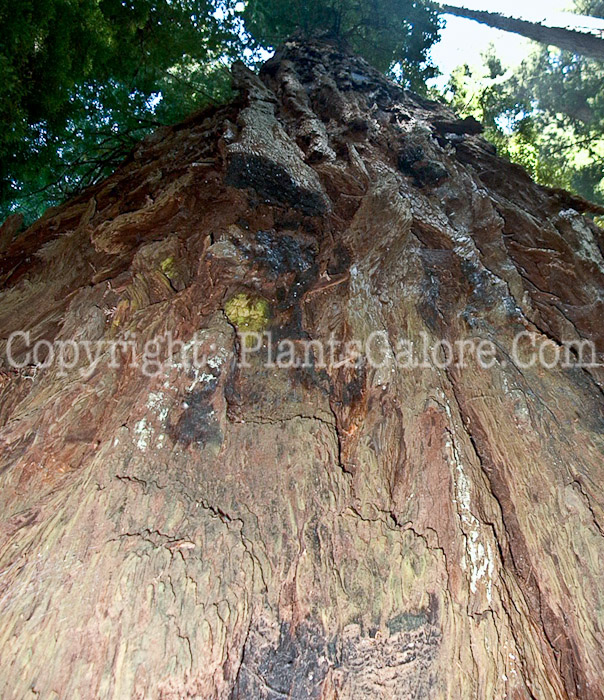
<box><xmin>448</xmin><ymin>34</ymin><xmax>604</xmax><ymax>208</ymax></box>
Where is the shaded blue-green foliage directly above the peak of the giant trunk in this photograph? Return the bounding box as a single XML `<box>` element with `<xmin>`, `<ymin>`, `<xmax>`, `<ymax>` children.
<box><xmin>242</xmin><ymin>0</ymin><xmax>440</xmax><ymax>89</ymax></box>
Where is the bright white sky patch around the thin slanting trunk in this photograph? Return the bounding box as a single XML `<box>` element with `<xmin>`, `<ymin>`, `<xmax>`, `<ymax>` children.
<box><xmin>432</xmin><ymin>0</ymin><xmax>604</xmax><ymax>87</ymax></box>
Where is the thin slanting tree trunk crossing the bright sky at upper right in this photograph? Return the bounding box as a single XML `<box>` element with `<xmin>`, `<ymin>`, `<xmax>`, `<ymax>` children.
<box><xmin>439</xmin><ymin>5</ymin><xmax>604</xmax><ymax>61</ymax></box>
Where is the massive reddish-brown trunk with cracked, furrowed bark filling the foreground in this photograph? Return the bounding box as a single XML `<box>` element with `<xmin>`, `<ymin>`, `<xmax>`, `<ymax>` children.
<box><xmin>0</xmin><ymin>42</ymin><xmax>604</xmax><ymax>700</ymax></box>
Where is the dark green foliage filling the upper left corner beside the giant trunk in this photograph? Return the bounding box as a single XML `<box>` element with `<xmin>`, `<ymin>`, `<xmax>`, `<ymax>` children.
<box><xmin>0</xmin><ymin>0</ymin><xmax>237</xmax><ymax>220</ymax></box>
